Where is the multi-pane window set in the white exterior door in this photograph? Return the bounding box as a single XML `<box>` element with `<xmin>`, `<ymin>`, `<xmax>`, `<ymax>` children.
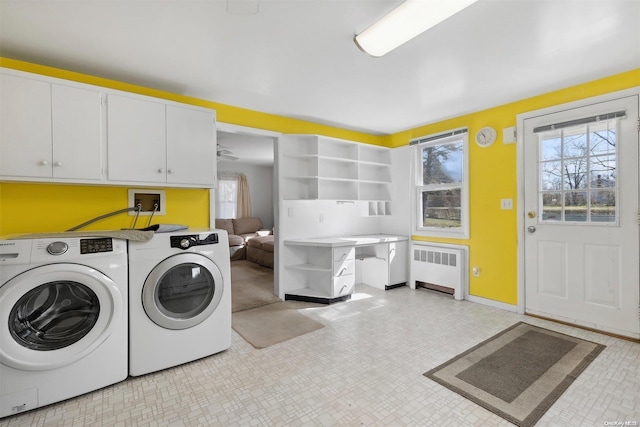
<box><xmin>538</xmin><ymin>119</ymin><xmax>618</xmax><ymax>224</ymax></box>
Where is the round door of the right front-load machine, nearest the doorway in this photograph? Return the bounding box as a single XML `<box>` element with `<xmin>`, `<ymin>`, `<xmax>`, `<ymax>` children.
<box><xmin>142</xmin><ymin>252</ymin><xmax>224</xmax><ymax>329</ymax></box>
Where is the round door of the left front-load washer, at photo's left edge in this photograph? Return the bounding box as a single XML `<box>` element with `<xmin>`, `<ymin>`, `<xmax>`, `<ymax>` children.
<box><xmin>0</xmin><ymin>264</ymin><xmax>126</xmax><ymax>370</ymax></box>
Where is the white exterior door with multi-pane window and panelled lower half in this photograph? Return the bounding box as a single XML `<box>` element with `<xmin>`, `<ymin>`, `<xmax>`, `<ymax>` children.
<box><xmin>522</xmin><ymin>95</ymin><xmax>640</xmax><ymax>338</ymax></box>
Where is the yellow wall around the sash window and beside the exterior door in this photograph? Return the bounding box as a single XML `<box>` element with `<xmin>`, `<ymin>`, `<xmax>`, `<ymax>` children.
<box><xmin>392</xmin><ymin>69</ymin><xmax>640</xmax><ymax>305</ymax></box>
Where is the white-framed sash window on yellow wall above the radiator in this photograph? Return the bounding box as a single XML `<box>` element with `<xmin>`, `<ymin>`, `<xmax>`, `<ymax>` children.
<box><xmin>411</xmin><ymin>129</ymin><xmax>469</xmax><ymax>237</ymax></box>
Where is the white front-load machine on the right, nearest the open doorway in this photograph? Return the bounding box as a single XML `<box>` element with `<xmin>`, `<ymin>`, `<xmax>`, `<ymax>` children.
<box><xmin>129</xmin><ymin>230</ymin><xmax>231</xmax><ymax>376</ymax></box>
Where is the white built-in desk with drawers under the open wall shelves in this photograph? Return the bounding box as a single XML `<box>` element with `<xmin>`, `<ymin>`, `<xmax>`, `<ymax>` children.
<box><xmin>283</xmin><ymin>234</ymin><xmax>409</xmax><ymax>304</ymax></box>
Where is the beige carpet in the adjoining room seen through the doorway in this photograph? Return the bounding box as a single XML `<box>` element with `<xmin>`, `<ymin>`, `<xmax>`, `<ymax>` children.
<box><xmin>231</xmin><ymin>260</ymin><xmax>280</xmax><ymax>313</ymax></box>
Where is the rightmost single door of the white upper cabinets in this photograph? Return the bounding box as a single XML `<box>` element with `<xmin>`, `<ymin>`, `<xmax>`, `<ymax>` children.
<box><xmin>167</xmin><ymin>105</ymin><xmax>217</xmax><ymax>187</ymax></box>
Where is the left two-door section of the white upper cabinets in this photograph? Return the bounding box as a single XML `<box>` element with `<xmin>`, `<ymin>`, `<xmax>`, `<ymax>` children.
<box><xmin>0</xmin><ymin>74</ymin><xmax>102</xmax><ymax>182</ymax></box>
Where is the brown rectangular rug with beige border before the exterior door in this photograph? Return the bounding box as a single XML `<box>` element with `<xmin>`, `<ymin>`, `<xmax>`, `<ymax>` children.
<box><xmin>424</xmin><ymin>322</ymin><xmax>605</xmax><ymax>427</ymax></box>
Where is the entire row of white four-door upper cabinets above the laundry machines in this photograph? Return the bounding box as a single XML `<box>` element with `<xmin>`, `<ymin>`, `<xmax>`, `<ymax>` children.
<box><xmin>0</xmin><ymin>68</ymin><xmax>217</xmax><ymax>188</ymax></box>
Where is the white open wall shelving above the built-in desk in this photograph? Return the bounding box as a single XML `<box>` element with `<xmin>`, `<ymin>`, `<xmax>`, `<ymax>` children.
<box><xmin>279</xmin><ymin>135</ymin><xmax>391</xmax><ymax>211</ymax></box>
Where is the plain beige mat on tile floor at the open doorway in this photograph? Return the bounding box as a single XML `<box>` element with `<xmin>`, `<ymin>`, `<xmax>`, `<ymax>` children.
<box><xmin>231</xmin><ymin>301</ymin><xmax>324</xmax><ymax>348</ymax></box>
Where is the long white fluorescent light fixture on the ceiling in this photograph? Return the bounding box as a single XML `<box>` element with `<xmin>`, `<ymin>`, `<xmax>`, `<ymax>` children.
<box><xmin>354</xmin><ymin>0</ymin><xmax>477</xmax><ymax>57</ymax></box>
